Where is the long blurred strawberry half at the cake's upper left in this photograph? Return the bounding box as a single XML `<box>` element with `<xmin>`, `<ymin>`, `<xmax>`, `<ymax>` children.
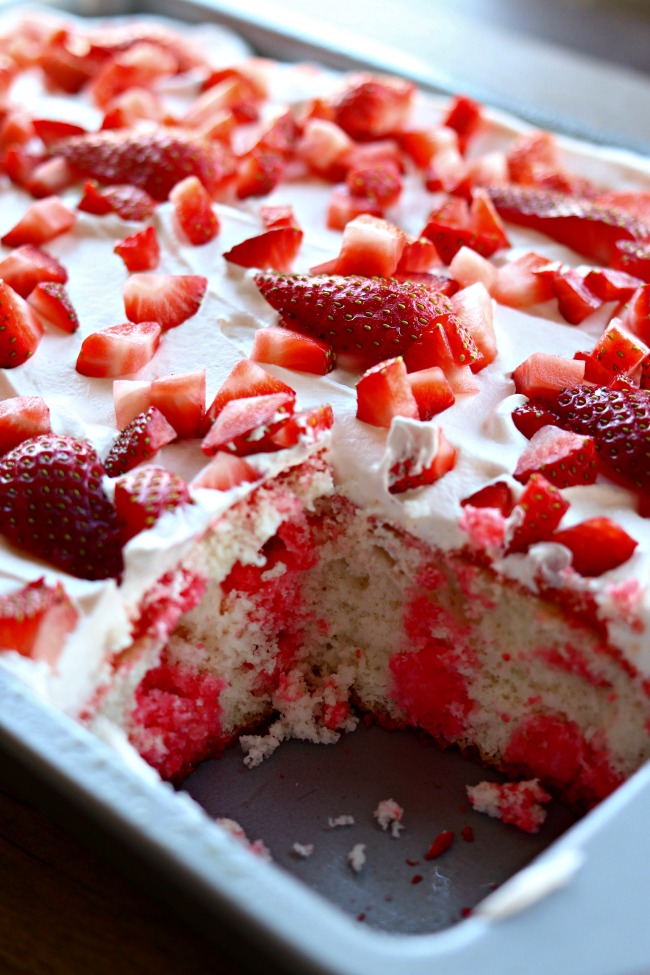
<box><xmin>53</xmin><ymin>128</ymin><xmax>233</xmax><ymax>201</ymax></box>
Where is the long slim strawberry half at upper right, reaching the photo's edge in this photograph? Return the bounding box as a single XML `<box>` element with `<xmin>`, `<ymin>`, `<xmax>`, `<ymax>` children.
<box><xmin>489</xmin><ymin>185</ymin><xmax>650</xmax><ymax>264</ymax></box>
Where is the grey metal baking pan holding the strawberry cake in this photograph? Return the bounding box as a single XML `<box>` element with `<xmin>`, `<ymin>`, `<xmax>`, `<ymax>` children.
<box><xmin>0</xmin><ymin>0</ymin><xmax>650</xmax><ymax>975</ymax></box>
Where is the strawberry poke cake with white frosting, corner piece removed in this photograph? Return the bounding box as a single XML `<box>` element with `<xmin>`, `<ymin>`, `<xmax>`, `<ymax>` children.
<box><xmin>0</xmin><ymin>14</ymin><xmax>650</xmax><ymax>808</ymax></box>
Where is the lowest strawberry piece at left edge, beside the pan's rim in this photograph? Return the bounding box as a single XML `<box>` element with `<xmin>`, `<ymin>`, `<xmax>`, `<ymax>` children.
<box><xmin>0</xmin><ymin>579</ymin><xmax>79</xmax><ymax>665</ymax></box>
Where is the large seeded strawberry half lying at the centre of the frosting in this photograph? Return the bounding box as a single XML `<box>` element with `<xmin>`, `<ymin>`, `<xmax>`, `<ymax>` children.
<box><xmin>255</xmin><ymin>272</ymin><xmax>460</xmax><ymax>364</ymax></box>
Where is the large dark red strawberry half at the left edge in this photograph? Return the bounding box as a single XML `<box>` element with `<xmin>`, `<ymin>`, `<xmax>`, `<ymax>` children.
<box><xmin>0</xmin><ymin>433</ymin><xmax>122</xmax><ymax>579</ymax></box>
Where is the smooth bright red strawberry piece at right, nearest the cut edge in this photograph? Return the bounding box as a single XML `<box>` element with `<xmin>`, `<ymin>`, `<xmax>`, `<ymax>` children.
<box><xmin>553</xmin><ymin>518</ymin><xmax>638</xmax><ymax>577</ymax></box>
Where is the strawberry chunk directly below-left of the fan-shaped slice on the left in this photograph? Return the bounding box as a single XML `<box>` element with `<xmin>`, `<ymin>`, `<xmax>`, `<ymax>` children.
<box><xmin>76</xmin><ymin>322</ymin><xmax>161</xmax><ymax>379</ymax></box>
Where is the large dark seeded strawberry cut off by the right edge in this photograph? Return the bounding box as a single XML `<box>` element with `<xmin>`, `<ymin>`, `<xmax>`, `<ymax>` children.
<box><xmin>548</xmin><ymin>384</ymin><xmax>650</xmax><ymax>496</ymax></box>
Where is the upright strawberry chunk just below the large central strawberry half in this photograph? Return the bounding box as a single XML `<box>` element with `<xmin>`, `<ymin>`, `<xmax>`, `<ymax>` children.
<box><xmin>357</xmin><ymin>356</ymin><xmax>420</xmax><ymax>429</ymax></box>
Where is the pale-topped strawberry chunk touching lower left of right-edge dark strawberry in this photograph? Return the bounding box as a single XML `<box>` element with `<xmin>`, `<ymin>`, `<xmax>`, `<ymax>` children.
<box><xmin>514</xmin><ymin>426</ymin><xmax>598</xmax><ymax>488</ymax></box>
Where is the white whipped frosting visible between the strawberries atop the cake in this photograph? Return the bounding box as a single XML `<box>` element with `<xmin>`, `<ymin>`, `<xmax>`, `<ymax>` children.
<box><xmin>0</xmin><ymin>7</ymin><xmax>650</xmax><ymax>711</ymax></box>
